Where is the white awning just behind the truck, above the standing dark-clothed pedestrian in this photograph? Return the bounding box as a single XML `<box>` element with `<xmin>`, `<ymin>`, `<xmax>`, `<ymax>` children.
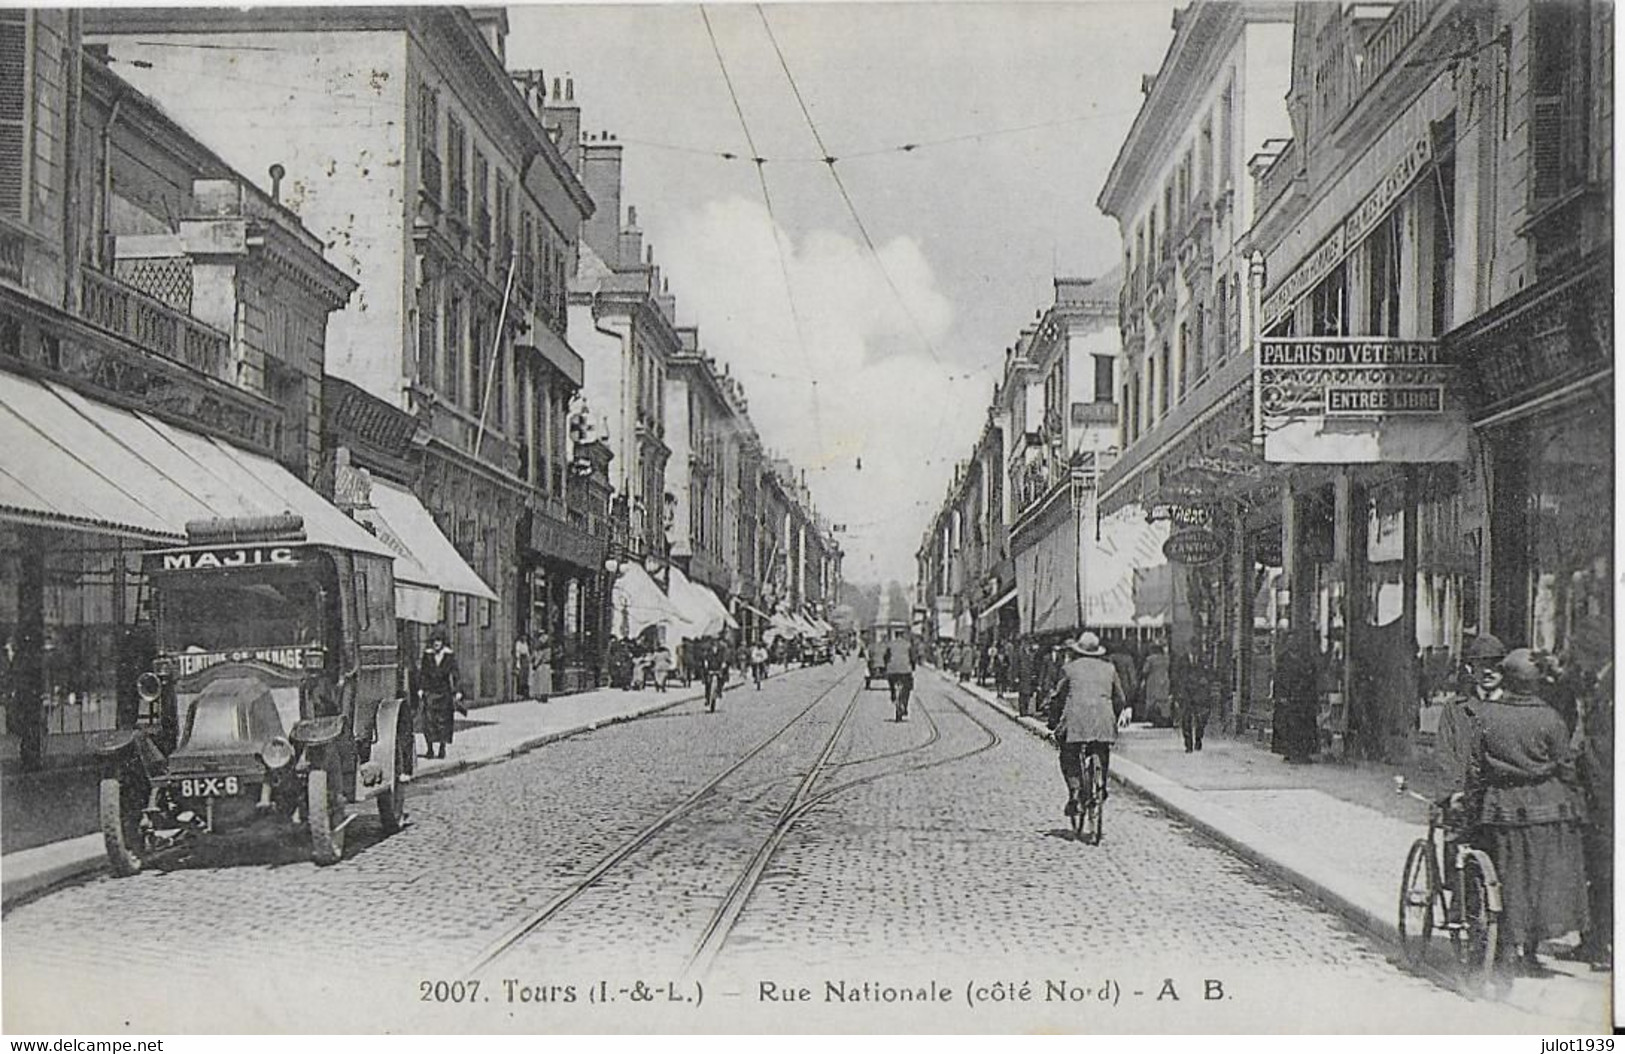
<box><xmin>361</xmin><ymin>479</ymin><xmax>497</xmax><ymax>624</ymax></box>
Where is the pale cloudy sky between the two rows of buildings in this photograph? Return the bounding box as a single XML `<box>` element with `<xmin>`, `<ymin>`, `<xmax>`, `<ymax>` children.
<box><xmin>507</xmin><ymin>2</ymin><xmax>1173</xmax><ymax>583</ymax></box>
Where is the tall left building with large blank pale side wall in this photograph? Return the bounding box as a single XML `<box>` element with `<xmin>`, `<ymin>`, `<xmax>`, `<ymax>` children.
<box><xmin>91</xmin><ymin>8</ymin><xmax>601</xmax><ymax>700</ymax></box>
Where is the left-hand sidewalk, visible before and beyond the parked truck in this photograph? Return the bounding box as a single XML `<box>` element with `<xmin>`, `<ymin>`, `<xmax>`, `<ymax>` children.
<box><xmin>0</xmin><ymin>682</ymin><xmax>724</xmax><ymax>906</ymax></box>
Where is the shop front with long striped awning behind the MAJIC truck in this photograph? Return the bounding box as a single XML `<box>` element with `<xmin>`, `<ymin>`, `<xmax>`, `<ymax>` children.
<box><xmin>0</xmin><ymin>372</ymin><xmax>386</xmax><ymax>767</ymax></box>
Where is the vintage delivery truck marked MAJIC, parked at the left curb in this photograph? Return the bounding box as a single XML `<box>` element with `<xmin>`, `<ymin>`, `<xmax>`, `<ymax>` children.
<box><xmin>98</xmin><ymin>515</ymin><xmax>413</xmax><ymax>875</ymax></box>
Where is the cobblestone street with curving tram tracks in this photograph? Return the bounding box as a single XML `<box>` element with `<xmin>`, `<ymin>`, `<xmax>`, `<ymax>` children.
<box><xmin>3</xmin><ymin>664</ymin><xmax>1573</xmax><ymax>1031</ymax></box>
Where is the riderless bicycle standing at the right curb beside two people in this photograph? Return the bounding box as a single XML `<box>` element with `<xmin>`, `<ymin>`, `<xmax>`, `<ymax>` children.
<box><xmin>1394</xmin><ymin>776</ymin><xmax>1502</xmax><ymax>992</ymax></box>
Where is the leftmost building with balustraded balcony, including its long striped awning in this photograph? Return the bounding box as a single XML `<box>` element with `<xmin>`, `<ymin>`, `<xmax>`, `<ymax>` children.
<box><xmin>0</xmin><ymin>8</ymin><xmax>355</xmax><ymax>767</ymax></box>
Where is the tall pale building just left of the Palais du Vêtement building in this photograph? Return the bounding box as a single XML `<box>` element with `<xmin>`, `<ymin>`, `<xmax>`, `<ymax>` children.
<box><xmin>1099</xmin><ymin>2</ymin><xmax>1295</xmax><ymax>737</ymax></box>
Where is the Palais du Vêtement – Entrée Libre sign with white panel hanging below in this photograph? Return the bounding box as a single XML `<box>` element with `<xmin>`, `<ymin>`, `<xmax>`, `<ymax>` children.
<box><xmin>1253</xmin><ymin>336</ymin><xmax>1467</xmax><ymax>464</ymax></box>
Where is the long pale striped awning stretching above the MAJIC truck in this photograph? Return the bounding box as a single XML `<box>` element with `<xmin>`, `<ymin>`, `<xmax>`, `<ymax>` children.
<box><xmin>0</xmin><ymin>372</ymin><xmax>393</xmax><ymax>555</ymax></box>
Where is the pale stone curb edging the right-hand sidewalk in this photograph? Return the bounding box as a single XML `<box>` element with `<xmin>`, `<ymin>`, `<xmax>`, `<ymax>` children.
<box><xmin>954</xmin><ymin>682</ymin><xmax>1399</xmax><ymax>945</ymax></box>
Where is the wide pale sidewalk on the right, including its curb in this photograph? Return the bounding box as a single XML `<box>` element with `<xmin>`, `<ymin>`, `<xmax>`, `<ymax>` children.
<box><xmin>944</xmin><ymin>674</ymin><xmax>1612</xmax><ymax>1031</ymax></box>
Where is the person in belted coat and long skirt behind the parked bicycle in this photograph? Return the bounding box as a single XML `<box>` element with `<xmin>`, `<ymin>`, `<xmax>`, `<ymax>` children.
<box><xmin>1466</xmin><ymin>648</ymin><xmax>1589</xmax><ymax>976</ymax></box>
